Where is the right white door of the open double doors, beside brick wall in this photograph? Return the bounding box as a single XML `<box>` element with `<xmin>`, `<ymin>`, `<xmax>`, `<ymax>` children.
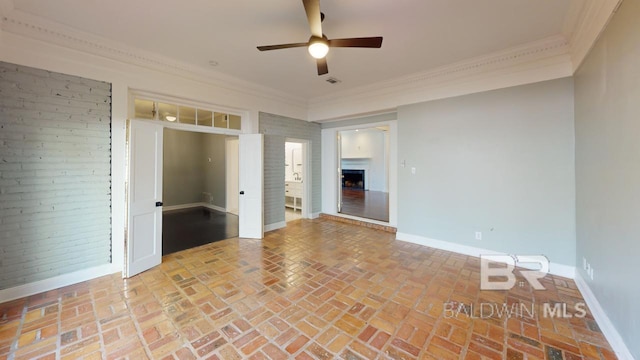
<box><xmin>238</xmin><ymin>134</ymin><xmax>264</xmax><ymax>239</ymax></box>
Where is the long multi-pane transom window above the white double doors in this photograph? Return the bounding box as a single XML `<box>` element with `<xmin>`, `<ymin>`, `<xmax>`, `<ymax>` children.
<box><xmin>134</xmin><ymin>98</ymin><xmax>242</xmax><ymax>130</ymax></box>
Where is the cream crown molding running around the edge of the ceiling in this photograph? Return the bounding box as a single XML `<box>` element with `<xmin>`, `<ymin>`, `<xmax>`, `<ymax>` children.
<box><xmin>0</xmin><ymin>0</ymin><xmax>622</xmax><ymax>121</ymax></box>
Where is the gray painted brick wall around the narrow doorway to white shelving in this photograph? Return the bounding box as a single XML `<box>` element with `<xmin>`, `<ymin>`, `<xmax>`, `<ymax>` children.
<box><xmin>259</xmin><ymin>113</ymin><xmax>322</xmax><ymax>225</ymax></box>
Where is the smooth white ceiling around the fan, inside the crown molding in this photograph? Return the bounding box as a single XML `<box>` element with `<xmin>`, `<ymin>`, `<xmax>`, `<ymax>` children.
<box><xmin>8</xmin><ymin>0</ymin><xmax>581</xmax><ymax>100</ymax></box>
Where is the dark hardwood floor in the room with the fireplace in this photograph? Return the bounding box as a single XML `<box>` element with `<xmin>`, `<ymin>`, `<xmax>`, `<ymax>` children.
<box><xmin>341</xmin><ymin>188</ymin><xmax>389</xmax><ymax>222</ymax></box>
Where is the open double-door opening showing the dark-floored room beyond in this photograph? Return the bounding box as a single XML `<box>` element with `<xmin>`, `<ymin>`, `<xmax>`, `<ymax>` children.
<box><xmin>162</xmin><ymin>128</ymin><xmax>239</xmax><ymax>255</ymax></box>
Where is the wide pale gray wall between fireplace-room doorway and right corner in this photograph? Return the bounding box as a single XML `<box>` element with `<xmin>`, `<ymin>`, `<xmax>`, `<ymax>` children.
<box><xmin>398</xmin><ymin>78</ymin><xmax>575</xmax><ymax>266</ymax></box>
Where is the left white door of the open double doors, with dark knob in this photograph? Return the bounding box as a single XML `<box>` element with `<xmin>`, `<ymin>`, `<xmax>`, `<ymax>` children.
<box><xmin>125</xmin><ymin>120</ymin><xmax>163</xmax><ymax>277</ymax></box>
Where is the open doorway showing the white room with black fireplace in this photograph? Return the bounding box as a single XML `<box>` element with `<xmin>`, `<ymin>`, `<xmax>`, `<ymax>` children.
<box><xmin>338</xmin><ymin>125</ymin><xmax>390</xmax><ymax>222</ymax></box>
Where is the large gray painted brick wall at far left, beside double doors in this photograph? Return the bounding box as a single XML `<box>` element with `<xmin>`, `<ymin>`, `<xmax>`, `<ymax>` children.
<box><xmin>0</xmin><ymin>62</ymin><xmax>111</xmax><ymax>289</ymax></box>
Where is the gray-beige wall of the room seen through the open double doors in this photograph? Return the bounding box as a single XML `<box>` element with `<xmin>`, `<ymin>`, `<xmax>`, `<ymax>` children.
<box><xmin>162</xmin><ymin>129</ymin><xmax>226</xmax><ymax>208</ymax></box>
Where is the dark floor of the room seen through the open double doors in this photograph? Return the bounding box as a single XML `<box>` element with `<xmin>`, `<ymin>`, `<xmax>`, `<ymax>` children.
<box><xmin>162</xmin><ymin>208</ymin><xmax>238</xmax><ymax>255</ymax></box>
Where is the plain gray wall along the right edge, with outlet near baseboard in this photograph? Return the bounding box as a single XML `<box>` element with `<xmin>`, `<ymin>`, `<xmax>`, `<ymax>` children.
<box><xmin>575</xmin><ymin>1</ymin><xmax>640</xmax><ymax>359</ymax></box>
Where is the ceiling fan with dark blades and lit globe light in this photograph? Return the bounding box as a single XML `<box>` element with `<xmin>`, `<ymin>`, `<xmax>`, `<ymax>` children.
<box><xmin>258</xmin><ymin>0</ymin><xmax>382</xmax><ymax>75</ymax></box>
